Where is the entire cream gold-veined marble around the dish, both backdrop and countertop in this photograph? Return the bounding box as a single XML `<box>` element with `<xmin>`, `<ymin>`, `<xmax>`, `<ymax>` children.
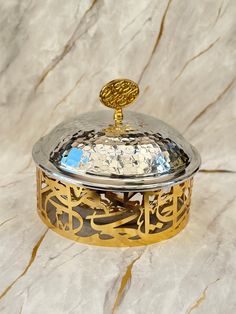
<box><xmin>0</xmin><ymin>0</ymin><xmax>236</xmax><ymax>314</ymax></box>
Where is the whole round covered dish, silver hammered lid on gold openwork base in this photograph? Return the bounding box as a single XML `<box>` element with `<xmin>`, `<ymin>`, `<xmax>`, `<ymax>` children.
<box><xmin>33</xmin><ymin>79</ymin><xmax>200</xmax><ymax>246</ymax></box>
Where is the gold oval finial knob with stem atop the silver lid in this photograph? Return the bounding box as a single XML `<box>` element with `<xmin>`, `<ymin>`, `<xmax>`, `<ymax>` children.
<box><xmin>99</xmin><ymin>79</ymin><xmax>139</xmax><ymax>124</ymax></box>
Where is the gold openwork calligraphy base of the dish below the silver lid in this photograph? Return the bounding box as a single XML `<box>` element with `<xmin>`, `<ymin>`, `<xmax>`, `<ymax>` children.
<box><xmin>37</xmin><ymin>169</ymin><xmax>192</xmax><ymax>246</ymax></box>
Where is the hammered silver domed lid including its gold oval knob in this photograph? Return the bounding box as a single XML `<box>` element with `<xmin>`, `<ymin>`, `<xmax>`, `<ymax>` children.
<box><xmin>33</xmin><ymin>79</ymin><xmax>200</xmax><ymax>191</ymax></box>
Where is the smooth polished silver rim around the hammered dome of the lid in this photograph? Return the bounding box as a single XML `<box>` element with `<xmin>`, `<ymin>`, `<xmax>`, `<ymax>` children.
<box><xmin>32</xmin><ymin>138</ymin><xmax>201</xmax><ymax>192</ymax></box>
